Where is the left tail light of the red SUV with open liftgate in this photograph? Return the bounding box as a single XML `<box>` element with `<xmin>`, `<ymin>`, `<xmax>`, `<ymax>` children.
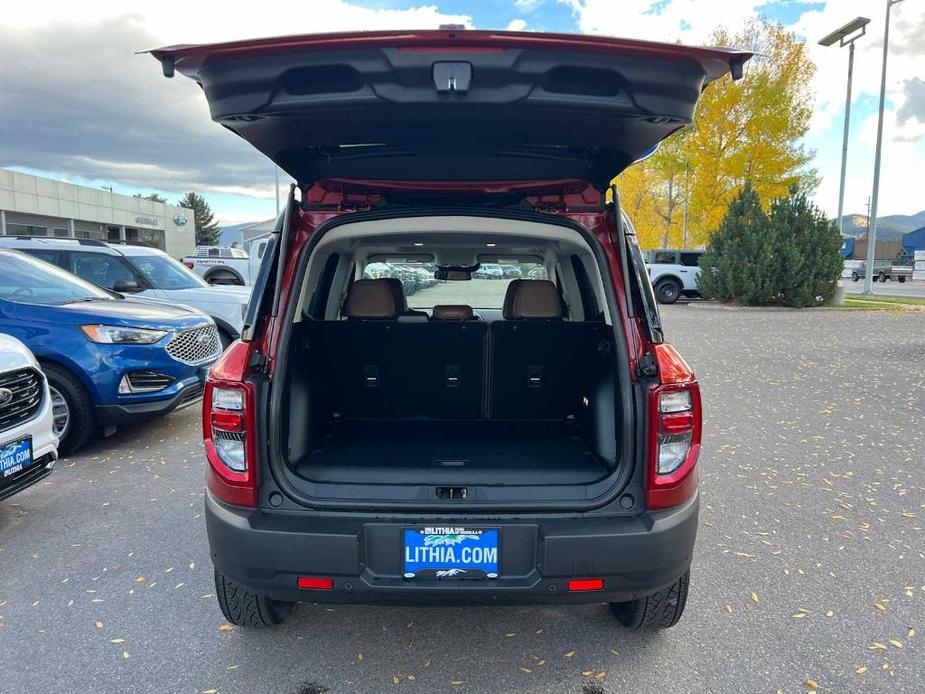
<box><xmin>202</xmin><ymin>342</ymin><xmax>257</xmax><ymax>507</ymax></box>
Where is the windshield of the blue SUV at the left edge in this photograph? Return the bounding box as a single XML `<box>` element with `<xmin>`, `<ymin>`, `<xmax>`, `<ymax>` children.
<box><xmin>0</xmin><ymin>253</ymin><xmax>112</xmax><ymax>306</ymax></box>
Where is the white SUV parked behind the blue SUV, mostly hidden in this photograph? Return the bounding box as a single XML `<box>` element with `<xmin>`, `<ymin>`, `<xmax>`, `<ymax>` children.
<box><xmin>0</xmin><ymin>236</ymin><xmax>250</xmax><ymax>348</ymax></box>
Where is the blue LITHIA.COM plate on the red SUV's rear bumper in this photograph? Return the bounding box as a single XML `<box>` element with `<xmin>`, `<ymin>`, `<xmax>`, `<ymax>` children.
<box><xmin>402</xmin><ymin>527</ymin><xmax>500</xmax><ymax>578</ymax></box>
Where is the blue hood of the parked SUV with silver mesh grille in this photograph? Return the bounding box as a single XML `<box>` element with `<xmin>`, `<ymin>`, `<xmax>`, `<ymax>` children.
<box><xmin>52</xmin><ymin>299</ymin><xmax>211</xmax><ymax>330</ymax></box>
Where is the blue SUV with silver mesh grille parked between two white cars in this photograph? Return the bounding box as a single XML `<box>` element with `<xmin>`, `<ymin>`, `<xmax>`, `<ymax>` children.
<box><xmin>0</xmin><ymin>249</ymin><xmax>222</xmax><ymax>455</ymax></box>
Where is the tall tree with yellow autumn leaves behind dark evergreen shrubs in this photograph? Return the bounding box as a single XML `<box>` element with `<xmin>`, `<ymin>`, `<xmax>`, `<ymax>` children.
<box><xmin>615</xmin><ymin>20</ymin><xmax>818</xmax><ymax>248</ymax></box>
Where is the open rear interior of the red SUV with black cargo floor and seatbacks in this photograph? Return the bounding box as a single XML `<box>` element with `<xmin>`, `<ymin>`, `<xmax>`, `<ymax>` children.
<box><xmin>272</xmin><ymin>215</ymin><xmax>623</xmax><ymax>502</ymax></box>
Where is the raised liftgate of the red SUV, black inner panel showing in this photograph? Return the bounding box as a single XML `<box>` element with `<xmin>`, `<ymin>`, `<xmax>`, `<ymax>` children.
<box><xmin>151</xmin><ymin>30</ymin><xmax>751</xmax><ymax>190</ymax></box>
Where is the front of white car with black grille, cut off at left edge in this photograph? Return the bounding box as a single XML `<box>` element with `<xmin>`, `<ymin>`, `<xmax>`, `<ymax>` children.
<box><xmin>0</xmin><ymin>334</ymin><xmax>58</xmax><ymax>500</ymax></box>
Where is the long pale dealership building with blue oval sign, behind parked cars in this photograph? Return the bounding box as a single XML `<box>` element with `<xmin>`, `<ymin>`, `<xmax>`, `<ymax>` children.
<box><xmin>0</xmin><ymin>169</ymin><xmax>196</xmax><ymax>258</ymax></box>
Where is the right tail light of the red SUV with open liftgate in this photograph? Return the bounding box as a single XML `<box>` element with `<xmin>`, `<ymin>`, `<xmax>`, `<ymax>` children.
<box><xmin>646</xmin><ymin>345</ymin><xmax>701</xmax><ymax>509</ymax></box>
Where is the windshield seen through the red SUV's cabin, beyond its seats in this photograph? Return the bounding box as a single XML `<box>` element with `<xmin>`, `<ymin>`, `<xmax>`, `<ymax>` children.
<box><xmin>363</xmin><ymin>259</ymin><xmax>549</xmax><ymax>309</ymax></box>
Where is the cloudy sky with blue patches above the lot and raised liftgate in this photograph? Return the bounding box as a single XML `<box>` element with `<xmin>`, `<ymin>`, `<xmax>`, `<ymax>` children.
<box><xmin>0</xmin><ymin>0</ymin><xmax>925</xmax><ymax>224</ymax></box>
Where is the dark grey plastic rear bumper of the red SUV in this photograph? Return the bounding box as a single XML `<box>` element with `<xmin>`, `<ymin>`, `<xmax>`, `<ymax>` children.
<box><xmin>206</xmin><ymin>493</ymin><xmax>699</xmax><ymax>604</ymax></box>
